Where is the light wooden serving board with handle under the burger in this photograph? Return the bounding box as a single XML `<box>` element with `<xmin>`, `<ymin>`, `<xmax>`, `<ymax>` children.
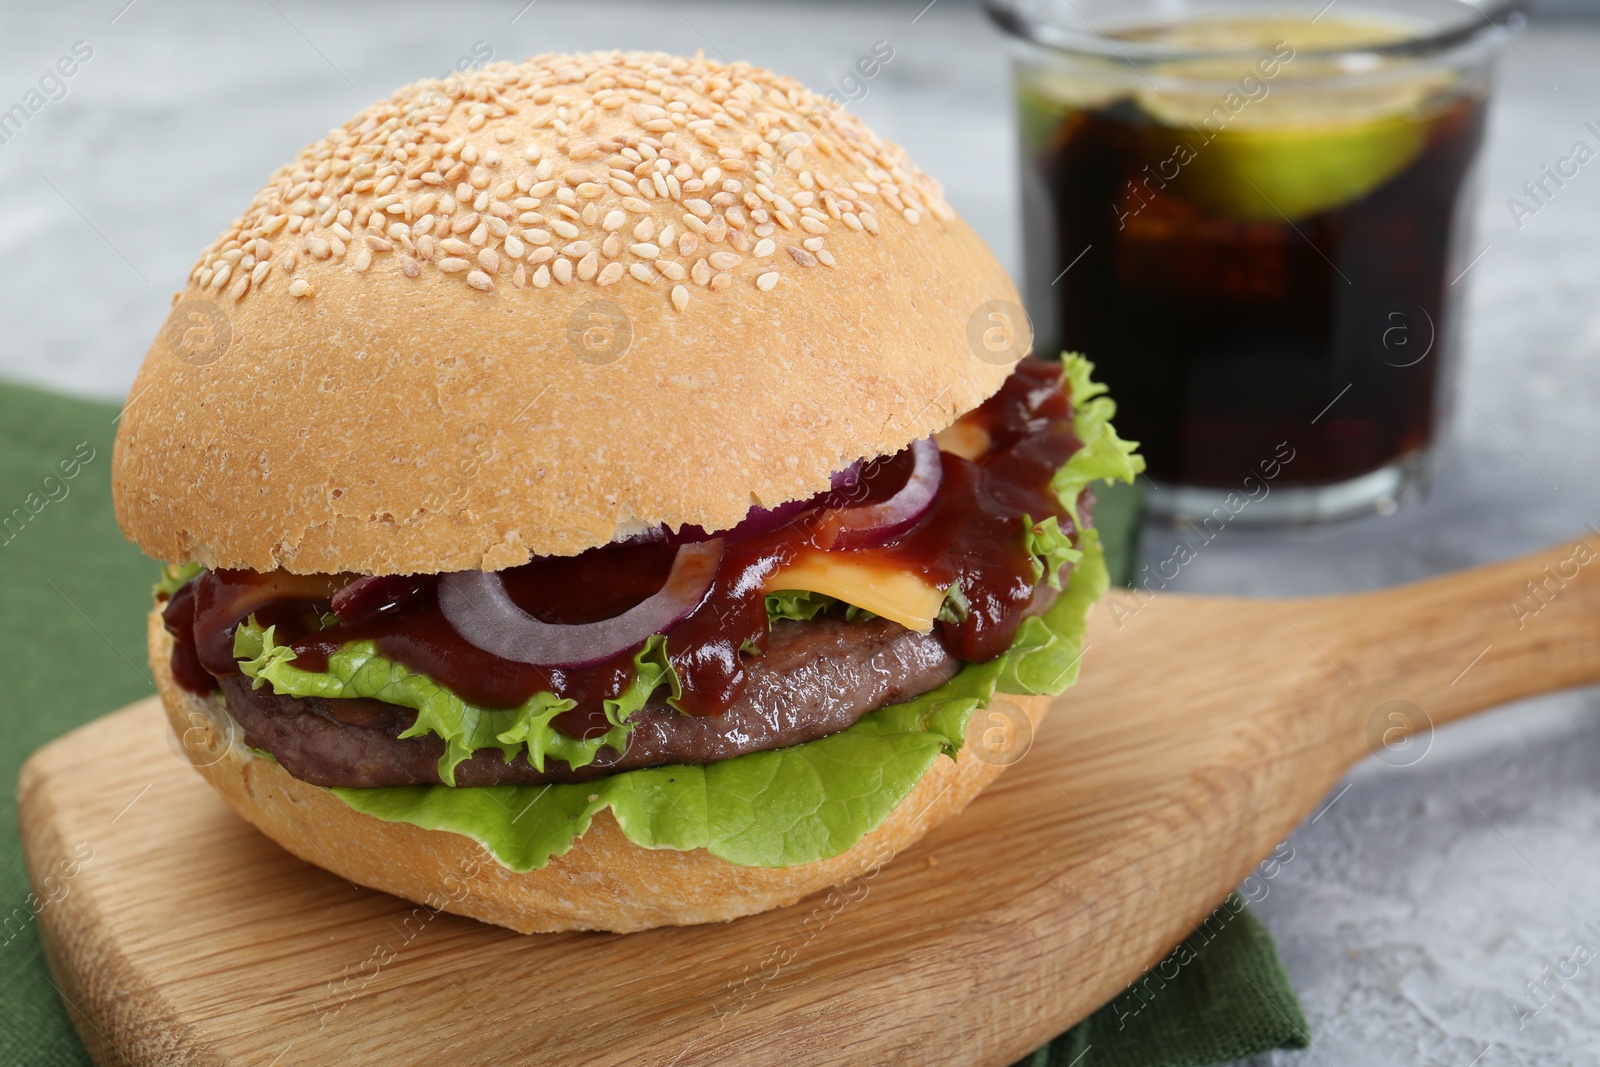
<box><xmin>21</xmin><ymin>536</ymin><xmax>1600</xmax><ymax>1067</ymax></box>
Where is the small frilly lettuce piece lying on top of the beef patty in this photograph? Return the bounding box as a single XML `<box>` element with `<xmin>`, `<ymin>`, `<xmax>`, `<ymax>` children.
<box><xmin>234</xmin><ymin>627</ymin><xmax>682</xmax><ymax>787</ymax></box>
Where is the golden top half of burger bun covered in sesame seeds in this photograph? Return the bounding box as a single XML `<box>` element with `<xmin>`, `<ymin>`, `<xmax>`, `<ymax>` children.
<box><xmin>114</xmin><ymin>53</ymin><xmax>1029</xmax><ymax>575</ymax></box>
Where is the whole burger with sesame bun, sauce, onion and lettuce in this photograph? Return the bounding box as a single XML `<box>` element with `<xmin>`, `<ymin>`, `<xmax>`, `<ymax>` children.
<box><xmin>114</xmin><ymin>53</ymin><xmax>1141</xmax><ymax>933</ymax></box>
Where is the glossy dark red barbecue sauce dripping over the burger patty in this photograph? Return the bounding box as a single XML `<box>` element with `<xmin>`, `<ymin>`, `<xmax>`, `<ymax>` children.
<box><xmin>165</xmin><ymin>358</ymin><xmax>1088</xmax><ymax>736</ymax></box>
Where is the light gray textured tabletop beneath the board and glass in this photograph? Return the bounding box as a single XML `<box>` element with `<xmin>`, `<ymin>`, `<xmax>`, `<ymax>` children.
<box><xmin>0</xmin><ymin>0</ymin><xmax>1600</xmax><ymax>1067</ymax></box>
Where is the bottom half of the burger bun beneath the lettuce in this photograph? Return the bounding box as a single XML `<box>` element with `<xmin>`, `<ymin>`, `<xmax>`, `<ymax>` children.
<box><xmin>149</xmin><ymin>613</ymin><xmax>1050</xmax><ymax>934</ymax></box>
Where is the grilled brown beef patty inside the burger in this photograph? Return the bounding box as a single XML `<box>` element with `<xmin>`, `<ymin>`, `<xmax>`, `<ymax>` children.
<box><xmin>222</xmin><ymin>607</ymin><xmax>966</xmax><ymax>787</ymax></box>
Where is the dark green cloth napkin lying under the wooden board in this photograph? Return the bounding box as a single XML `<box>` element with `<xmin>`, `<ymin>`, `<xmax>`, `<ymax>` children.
<box><xmin>0</xmin><ymin>384</ymin><xmax>1307</xmax><ymax>1067</ymax></box>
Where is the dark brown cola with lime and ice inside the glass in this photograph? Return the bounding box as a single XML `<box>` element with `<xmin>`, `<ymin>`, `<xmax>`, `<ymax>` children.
<box><xmin>1019</xmin><ymin>13</ymin><xmax>1485</xmax><ymax>518</ymax></box>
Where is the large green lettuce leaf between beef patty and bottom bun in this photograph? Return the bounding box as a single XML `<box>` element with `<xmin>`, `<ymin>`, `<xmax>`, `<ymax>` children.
<box><xmin>321</xmin><ymin>355</ymin><xmax>1144</xmax><ymax>872</ymax></box>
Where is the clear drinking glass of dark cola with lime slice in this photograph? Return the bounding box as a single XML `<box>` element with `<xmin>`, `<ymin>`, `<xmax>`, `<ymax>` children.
<box><xmin>987</xmin><ymin>0</ymin><xmax>1522</xmax><ymax>523</ymax></box>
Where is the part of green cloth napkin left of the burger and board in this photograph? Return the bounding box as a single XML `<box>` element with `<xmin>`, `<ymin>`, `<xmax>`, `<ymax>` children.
<box><xmin>0</xmin><ymin>386</ymin><xmax>155</xmax><ymax>1065</ymax></box>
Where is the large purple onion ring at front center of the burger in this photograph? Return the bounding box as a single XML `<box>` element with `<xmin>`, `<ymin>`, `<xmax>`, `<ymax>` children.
<box><xmin>438</xmin><ymin>537</ymin><xmax>726</xmax><ymax>667</ymax></box>
